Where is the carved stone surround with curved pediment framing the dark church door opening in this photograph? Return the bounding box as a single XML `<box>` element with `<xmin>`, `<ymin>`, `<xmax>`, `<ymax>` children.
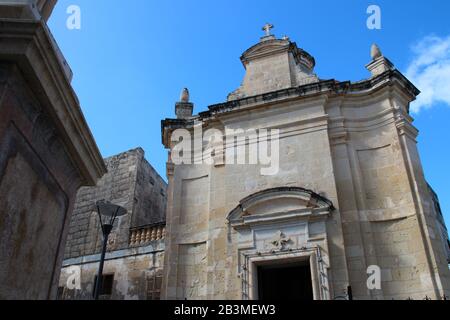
<box><xmin>227</xmin><ymin>187</ymin><xmax>334</xmax><ymax>300</ymax></box>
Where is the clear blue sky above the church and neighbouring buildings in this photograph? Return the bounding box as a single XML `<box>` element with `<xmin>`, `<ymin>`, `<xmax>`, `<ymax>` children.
<box><xmin>49</xmin><ymin>0</ymin><xmax>450</xmax><ymax>223</ymax></box>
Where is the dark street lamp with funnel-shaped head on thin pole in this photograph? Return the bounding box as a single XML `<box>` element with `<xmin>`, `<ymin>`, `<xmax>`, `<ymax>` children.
<box><xmin>94</xmin><ymin>201</ymin><xmax>127</xmax><ymax>300</ymax></box>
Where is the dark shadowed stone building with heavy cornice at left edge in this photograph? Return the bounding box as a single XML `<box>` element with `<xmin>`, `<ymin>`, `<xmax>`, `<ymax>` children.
<box><xmin>0</xmin><ymin>0</ymin><xmax>106</xmax><ymax>299</ymax></box>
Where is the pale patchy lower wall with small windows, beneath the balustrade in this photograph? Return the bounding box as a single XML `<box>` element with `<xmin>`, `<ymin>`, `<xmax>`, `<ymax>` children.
<box><xmin>58</xmin><ymin>240</ymin><xmax>164</xmax><ymax>300</ymax></box>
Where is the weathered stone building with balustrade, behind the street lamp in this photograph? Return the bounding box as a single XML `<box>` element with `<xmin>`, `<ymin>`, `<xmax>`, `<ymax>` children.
<box><xmin>59</xmin><ymin>148</ymin><xmax>167</xmax><ymax>300</ymax></box>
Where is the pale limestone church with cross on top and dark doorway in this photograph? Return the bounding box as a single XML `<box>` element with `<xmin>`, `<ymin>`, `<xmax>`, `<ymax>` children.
<box><xmin>162</xmin><ymin>25</ymin><xmax>450</xmax><ymax>300</ymax></box>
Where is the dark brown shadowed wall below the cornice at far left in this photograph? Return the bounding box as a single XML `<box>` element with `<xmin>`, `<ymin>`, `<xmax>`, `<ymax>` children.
<box><xmin>0</xmin><ymin>64</ymin><xmax>81</xmax><ymax>299</ymax></box>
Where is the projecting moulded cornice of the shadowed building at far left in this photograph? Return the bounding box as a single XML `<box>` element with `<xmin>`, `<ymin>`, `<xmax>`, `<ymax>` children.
<box><xmin>0</xmin><ymin>19</ymin><xmax>106</xmax><ymax>185</ymax></box>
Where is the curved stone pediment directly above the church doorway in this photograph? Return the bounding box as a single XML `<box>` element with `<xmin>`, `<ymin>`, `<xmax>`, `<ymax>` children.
<box><xmin>228</xmin><ymin>187</ymin><xmax>334</xmax><ymax>225</ymax></box>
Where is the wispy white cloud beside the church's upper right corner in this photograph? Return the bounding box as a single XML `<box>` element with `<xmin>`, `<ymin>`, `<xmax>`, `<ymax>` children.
<box><xmin>406</xmin><ymin>36</ymin><xmax>450</xmax><ymax>113</ymax></box>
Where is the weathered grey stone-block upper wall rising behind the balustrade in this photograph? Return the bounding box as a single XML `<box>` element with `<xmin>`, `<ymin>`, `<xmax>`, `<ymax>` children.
<box><xmin>65</xmin><ymin>148</ymin><xmax>166</xmax><ymax>259</ymax></box>
